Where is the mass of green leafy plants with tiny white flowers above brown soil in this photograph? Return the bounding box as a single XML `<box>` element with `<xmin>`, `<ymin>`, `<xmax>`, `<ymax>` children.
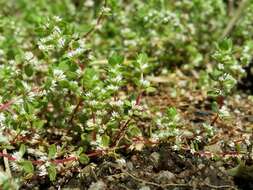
<box><xmin>0</xmin><ymin>0</ymin><xmax>253</xmax><ymax>186</ymax></box>
